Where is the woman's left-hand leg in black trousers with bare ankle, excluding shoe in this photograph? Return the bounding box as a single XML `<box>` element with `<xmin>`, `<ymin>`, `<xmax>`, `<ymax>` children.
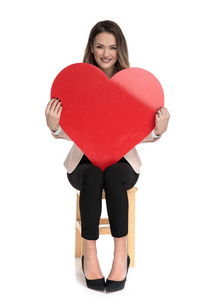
<box><xmin>68</xmin><ymin>163</ymin><xmax>103</xmax><ymax>279</ymax></box>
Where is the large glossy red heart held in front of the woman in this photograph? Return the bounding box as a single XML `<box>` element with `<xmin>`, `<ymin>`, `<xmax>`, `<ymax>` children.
<box><xmin>51</xmin><ymin>63</ymin><xmax>164</xmax><ymax>170</ymax></box>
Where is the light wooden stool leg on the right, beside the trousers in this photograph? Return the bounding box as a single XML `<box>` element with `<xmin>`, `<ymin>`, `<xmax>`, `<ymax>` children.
<box><xmin>127</xmin><ymin>191</ymin><xmax>135</xmax><ymax>267</ymax></box>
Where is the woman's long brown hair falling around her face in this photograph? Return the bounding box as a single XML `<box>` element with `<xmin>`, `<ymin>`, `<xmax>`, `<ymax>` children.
<box><xmin>83</xmin><ymin>21</ymin><xmax>130</xmax><ymax>72</ymax></box>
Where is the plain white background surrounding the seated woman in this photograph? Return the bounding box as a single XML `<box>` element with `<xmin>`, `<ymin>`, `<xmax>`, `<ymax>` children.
<box><xmin>0</xmin><ymin>0</ymin><xmax>200</xmax><ymax>300</ymax></box>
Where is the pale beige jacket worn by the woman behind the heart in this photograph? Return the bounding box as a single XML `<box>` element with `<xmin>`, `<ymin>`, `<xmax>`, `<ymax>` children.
<box><xmin>52</xmin><ymin>129</ymin><xmax>159</xmax><ymax>174</ymax></box>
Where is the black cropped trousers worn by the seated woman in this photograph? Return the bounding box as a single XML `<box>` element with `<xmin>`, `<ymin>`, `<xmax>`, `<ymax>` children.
<box><xmin>67</xmin><ymin>155</ymin><xmax>139</xmax><ymax>240</ymax></box>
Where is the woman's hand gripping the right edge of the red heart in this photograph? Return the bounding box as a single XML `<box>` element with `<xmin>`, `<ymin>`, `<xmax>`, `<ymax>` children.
<box><xmin>154</xmin><ymin>107</ymin><xmax>170</xmax><ymax>135</ymax></box>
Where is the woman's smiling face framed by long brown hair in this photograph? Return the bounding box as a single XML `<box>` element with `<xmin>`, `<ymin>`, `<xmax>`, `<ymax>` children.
<box><xmin>91</xmin><ymin>32</ymin><xmax>117</xmax><ymax>75</ymax></box>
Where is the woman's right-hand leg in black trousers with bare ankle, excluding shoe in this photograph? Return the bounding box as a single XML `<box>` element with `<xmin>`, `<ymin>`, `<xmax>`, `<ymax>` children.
<box><xmin>104</xmin><ymin>161</ymin><xmax>139</xmax><ymax>281</ymax></box>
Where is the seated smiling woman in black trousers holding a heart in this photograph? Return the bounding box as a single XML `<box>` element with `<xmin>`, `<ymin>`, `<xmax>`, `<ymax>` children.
<box><xmin>46</xmin><ymin>21</ymin><xmax>170</xmax><ymax>292</ymax></box>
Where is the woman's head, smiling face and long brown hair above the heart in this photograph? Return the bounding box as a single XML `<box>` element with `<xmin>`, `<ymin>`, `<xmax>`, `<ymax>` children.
<box><xmin>83</xmin><ymin>21</ymin><xmax>130</xmax><ymax>77</ymax></box>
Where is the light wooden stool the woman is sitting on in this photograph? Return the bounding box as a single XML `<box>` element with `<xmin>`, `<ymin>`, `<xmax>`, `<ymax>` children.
<box><xmin>75</xmin><ymin>187</ymin><xmax>137</xmax><ymax>267</ymax></box>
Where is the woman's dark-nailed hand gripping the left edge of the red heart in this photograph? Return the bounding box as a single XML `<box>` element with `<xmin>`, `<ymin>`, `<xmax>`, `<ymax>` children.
<box><xmin>45</xmin><ymin>98</ymin><xmax>62</xmax><ymax>131</ymax></box>
